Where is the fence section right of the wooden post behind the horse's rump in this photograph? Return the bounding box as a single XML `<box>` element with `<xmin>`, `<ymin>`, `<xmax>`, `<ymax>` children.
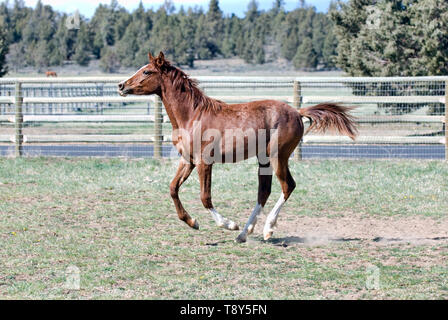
<box><xmin>296</xmin><ymin>77</ymin><xmax>446</xmax><ymax>159</ymax></box>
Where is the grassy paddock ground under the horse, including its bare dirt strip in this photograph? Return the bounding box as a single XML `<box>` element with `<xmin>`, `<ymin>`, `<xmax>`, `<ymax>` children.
<box><xmin>0</xmin><ymin>158</ymin><xmax>448</xmax><ymax>299</ymax></box>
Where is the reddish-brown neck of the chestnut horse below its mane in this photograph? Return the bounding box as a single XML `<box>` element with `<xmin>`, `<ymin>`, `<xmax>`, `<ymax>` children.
<box><xmin>161</xmin><ymin>75</ymin><xmax>194</xmax><ymax>129</ymax></box>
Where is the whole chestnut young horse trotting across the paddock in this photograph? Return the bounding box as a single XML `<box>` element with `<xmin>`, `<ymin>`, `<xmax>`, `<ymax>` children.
<box><xmin>118</xmin><ymin>52</ymin><xmax>357</xmax><ymax>242</ymax></box>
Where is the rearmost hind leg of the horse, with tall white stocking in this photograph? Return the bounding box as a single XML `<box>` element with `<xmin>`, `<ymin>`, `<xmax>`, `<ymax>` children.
<box><xmin>263</xmin><ymin>157</ymin><xmax>296</xmax><ymax>240</ymax></box>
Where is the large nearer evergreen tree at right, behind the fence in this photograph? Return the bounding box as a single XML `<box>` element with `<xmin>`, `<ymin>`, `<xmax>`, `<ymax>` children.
<box><xmin>331</xmin><ymin>0</ymin><xmax>434</xmax><ymax>76</ymax></box>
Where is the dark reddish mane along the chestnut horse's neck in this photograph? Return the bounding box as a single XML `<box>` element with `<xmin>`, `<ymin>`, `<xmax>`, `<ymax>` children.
<box><xmin>163</xmin><ymin>61</ymin><xmax>226</xmax><ymax>112</ymax></box>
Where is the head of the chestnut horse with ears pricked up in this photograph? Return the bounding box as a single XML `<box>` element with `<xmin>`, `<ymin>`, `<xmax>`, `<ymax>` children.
<box><xmin>118</xmin><ymin>52</ymin><xmax>168</xmax><ymax>96</ymax></box>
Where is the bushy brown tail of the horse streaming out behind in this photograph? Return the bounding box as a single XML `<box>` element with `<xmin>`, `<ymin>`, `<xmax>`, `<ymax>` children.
<box><xmin>299</xmin><ymin>103</ymin><xmax>358</xmax><ymax>140</ymax></box>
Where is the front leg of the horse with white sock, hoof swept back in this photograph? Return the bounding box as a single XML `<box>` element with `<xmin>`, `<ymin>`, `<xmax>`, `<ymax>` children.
<box><xmin>198</xmin><ymin>164</ymin><xmax>239</xmax><ymax>230</ymax></box>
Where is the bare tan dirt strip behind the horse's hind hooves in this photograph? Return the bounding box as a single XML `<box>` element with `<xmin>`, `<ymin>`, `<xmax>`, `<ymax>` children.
<box><xmin>260</xmin><ymin>213</ymin><xmax>448</xmax><ymax>245</ymax></box>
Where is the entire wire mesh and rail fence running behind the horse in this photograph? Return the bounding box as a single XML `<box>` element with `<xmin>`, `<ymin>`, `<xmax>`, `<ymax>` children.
<box><xmin>0</xmin><ymin>77</ymin><xmax>448</xmax><ymax>159</ymax></box>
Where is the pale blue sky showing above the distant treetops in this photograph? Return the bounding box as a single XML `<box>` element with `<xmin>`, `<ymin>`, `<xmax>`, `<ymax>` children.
<box><xmin>0</xmin><ymin>0</ymin><xmax>330</xmax><ymax>18</ymax></box>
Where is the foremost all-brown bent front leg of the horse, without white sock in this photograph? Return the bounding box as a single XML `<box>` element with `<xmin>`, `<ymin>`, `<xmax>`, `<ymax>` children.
<box><xmin>170</xmin><ymin>158</ymin><xmax>199</xmax><ymax>229</ymax></box>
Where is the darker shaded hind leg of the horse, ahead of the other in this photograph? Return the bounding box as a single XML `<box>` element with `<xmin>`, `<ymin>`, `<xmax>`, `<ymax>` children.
<box><xmin>235</xmin><ymin>163</ymin><xmax>272</xmax><ymax>243</ymax></box>
